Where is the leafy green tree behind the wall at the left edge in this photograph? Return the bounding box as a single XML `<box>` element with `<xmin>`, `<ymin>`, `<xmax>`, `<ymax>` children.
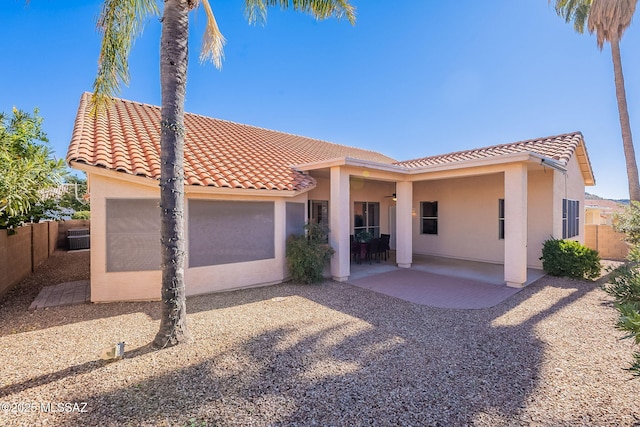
<box><xmin>0</xmin><ymin>108</ymin><xmax>65</xmax><ymax>228</ymax></box>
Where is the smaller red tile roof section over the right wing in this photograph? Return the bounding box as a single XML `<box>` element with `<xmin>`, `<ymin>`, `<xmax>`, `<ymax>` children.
<box><xmin>396</xmin><ymin>132</ymin><xmax>591</xmax><ymax>169</ymax></box>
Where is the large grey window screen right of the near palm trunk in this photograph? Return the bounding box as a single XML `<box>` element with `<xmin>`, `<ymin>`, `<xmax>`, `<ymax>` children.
<box><xmin>189</xmin><ymin>200</ymin><xmax>274</xmax><ymax>267</ymax></box>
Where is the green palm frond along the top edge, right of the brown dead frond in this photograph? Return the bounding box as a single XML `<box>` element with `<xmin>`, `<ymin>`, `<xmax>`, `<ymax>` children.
<box><xmin>244</xmin><ymin>0</ymin><xmax>356</xmax><ymax>25</ymax></box>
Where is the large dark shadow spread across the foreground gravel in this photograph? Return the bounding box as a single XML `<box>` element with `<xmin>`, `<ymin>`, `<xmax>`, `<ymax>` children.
<box><xmin>53</xmin><ymin>279</ymin><xmax>599</xmax><ymax>425</ymax></box>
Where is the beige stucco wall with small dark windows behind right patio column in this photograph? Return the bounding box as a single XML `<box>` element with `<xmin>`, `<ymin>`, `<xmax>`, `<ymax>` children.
<box><xmin>413</xmin><ymin>169</ymin><xmax>562</xmax><ymax>268</ymax></box>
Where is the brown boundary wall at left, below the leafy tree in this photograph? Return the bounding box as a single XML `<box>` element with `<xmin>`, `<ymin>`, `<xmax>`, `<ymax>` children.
<box><xmin>0</xmin><ymin>220</ymin><xmax>90</xmax><ymax>297</ymax></box>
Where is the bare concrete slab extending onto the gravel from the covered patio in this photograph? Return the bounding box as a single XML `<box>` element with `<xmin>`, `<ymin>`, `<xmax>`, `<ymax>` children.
<box><xmin>347</xmin><ymin>268</ymin><xmax>520</xmax><ymax>309</ymax></box>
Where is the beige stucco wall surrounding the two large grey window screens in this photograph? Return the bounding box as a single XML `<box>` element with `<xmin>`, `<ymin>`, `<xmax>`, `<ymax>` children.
<box><xmin>91</xmin><ymin>174</ymin><xmax>307</xmax><ymax>302</ymax></box>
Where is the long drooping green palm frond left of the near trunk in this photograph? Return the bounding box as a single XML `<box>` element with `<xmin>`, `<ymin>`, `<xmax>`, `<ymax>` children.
<box><xmin>92</xmin><ymin>0</ymin><xmax>159</xmax><ymax>113</ymax></box>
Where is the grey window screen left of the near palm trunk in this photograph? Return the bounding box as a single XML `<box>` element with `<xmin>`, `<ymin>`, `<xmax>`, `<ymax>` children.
<box><xmin>106</xmin><ymin>199</ymin><xmax>161</xmax><ymax>272</ymax></box>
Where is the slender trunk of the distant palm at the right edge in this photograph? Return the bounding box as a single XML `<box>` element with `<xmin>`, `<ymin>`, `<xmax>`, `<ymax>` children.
<box><xmin>610</xmin><ymin>38</ymin><xmax>640</xmax><ymax>201</ymax></box>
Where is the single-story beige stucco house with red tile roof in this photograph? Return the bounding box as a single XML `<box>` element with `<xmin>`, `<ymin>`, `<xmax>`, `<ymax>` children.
<box><xmin>67</xmin><ymin>93</ymin><xmax>595</xmax><ymax>302</ymax></box>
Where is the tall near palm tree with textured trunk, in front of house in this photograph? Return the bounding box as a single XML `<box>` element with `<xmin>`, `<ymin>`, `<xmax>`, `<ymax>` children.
<box><xmin>93</xmin><ymin>0</ymin><xmax>355</xmax><ymax>348</ymax></box>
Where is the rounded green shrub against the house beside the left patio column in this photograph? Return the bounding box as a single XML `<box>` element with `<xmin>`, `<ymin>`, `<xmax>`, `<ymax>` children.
<box><xmin>286</xmin><ymin>223</ymin><xmax>334</xmax><ymax>284</ymax></box>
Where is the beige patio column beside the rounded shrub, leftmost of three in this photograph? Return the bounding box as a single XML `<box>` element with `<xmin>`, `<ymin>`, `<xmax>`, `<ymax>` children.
<box><xmin>329</xmin><ymin>166</ymin><xmax>351</xmax><ymax>282</ymax></box>
